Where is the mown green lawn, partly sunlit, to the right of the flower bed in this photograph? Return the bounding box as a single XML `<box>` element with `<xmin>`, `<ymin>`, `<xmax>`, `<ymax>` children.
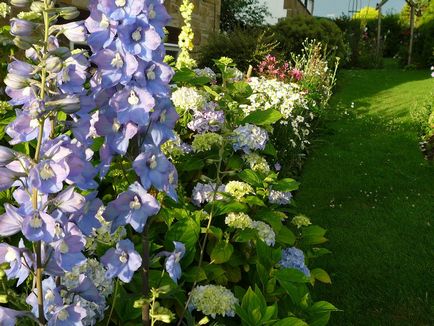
<box><xmin>296</xmin><ymin>69</ymin><xmax>434</xmax><ymax>326</ymax></box>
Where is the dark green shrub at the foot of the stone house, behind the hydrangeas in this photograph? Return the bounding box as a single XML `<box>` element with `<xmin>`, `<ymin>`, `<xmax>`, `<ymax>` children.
<box><xmin>199</xmin><ymin>28</ymin><xmax>277</xmax><ymax>71</ymax></box>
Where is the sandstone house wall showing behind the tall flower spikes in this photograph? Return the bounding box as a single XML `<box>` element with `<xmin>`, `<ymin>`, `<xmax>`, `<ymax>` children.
<box><xmin>62</xmin><ymin>0</ymin><xmax>221</xmax><ymax>45</ymax></box>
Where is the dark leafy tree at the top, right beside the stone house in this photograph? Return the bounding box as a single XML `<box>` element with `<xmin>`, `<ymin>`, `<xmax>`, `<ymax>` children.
<box><xmin>220</xmin><ymin>0</ymin><xmax>271</xmax><ymax>32</ymax></box>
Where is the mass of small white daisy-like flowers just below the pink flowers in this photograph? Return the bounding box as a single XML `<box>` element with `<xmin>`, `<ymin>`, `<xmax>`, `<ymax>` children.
<box><xmin>243</xmin><ymin>77</ymin><xmax>314</xmax><ymax>149</ymax></box>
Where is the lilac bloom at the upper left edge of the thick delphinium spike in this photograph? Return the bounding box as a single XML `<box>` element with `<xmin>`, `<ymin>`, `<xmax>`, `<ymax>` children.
<box><xmin>85</xmin><ymin>10</ymin><xmax>118</xmax><ymax>52</ymax></box>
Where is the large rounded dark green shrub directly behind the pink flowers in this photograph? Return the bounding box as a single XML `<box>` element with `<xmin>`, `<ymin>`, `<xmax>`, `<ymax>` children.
<box><xmin>272</xmin><ymin>15</ymin><xmax>347</xmax><ymax>63</ymax></box>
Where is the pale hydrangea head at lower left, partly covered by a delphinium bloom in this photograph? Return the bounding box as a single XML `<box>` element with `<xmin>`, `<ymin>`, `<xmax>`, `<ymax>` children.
<box><xmin>61</xmin><ymin>258</ymin><xmax>113</xmax><ymax>326</ymax></box>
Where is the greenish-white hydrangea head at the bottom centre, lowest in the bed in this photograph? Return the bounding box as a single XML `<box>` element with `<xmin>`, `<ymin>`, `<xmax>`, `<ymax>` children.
<box><xmin>189</xmin><ymin>285</ymin><xmax>238</xmax><ymax>318</ymax></box>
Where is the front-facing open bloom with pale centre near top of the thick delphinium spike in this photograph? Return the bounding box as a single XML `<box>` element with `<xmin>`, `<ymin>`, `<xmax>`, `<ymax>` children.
<box><xmin>118</xmin><ymin>15</ymin><xmax>162</xmax><ymax>60</ymax></box>
